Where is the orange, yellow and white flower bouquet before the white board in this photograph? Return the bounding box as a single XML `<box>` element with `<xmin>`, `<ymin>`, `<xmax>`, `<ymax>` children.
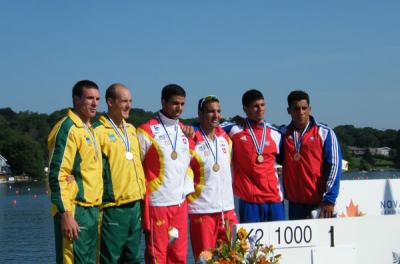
<box><xmin>198</xmin><ymin>225</ymin><xmax>281</xmax><ymax>264</ymax></box>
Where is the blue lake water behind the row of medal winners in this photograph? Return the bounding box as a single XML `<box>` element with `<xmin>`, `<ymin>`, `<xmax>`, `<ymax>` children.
<box><xmin>0</xmin><ymin>172</ymin><xmax>400</xmax><ymax>264</ymax></box>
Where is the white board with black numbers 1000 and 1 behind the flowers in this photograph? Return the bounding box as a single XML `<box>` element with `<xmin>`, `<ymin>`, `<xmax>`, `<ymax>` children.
<box><xmin>236</xmin><ymin>215</ymin><xmax>400</xmax><ymax>264</ymax></box>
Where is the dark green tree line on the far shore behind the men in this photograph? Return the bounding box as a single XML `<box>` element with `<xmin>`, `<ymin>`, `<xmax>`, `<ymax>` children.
<box><xmin>0</xmin><ymin>108</ymin><xmax>400</xmax><ymax>179</ymax></box>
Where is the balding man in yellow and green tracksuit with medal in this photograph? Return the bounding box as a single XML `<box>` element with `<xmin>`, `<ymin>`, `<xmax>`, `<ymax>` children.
<box><xmin>94</xmin><ymin>84</ymin><xmax>146</xmax><ymax>264</ymax></box>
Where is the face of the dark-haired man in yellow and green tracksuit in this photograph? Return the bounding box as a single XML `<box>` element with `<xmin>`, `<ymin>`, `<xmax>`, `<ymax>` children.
<box><xmin>73</xmin><ymin>87</ymin><xmax>100</xmax><ymax>122</ymax></box>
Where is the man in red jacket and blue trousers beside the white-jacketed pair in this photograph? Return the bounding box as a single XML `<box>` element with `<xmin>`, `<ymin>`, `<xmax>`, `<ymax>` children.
<box><xmin>223</xmin><ymin>90</ymin><xmax>285</xmax><ymax>223</ymax></box>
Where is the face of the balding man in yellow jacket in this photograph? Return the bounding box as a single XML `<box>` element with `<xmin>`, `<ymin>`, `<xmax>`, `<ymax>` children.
<box><xmin>107</xmin><ymin>85</ymin><xmax>132</xmax><ymax>121</ymax></box>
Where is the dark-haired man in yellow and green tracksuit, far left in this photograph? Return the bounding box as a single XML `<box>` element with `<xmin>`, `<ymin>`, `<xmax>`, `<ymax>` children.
<box><xmin>48</xmin><ymin>80</ymin><xmax>103</xmax><ymax>264</ymax></box>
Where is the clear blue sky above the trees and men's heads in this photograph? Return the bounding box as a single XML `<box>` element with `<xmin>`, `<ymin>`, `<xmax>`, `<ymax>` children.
<box><xmin>0</xmin><ymin>0</ymin><xmax>400</xmax><ymax>129</ymax></box>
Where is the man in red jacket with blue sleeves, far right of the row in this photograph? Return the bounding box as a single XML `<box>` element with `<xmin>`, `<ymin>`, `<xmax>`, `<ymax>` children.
<box><xmin>282</xmin><ymin>91</ymin><xmax>342</xmax><ymax>220</ymax></box>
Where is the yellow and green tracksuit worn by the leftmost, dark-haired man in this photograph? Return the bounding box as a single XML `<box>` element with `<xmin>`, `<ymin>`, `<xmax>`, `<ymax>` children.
<box><xmin>48</xmin><ymin>110</ymin><xmax>103</xmax><ymax>263</ymax></box>
